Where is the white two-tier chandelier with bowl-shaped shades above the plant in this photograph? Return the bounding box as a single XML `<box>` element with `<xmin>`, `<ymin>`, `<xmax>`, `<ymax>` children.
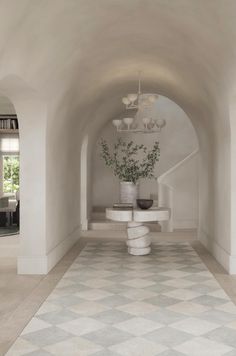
<box><xmin>112</xmin><ymin>75</ymin><xmax>166</xmax><ymax>133</ymax></box>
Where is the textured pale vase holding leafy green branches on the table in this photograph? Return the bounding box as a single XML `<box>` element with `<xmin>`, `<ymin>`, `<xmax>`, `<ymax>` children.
<box><xmin>101</xmin><ymin>138</ymin><xmax>160</xmax><ymax>206</ymax></box>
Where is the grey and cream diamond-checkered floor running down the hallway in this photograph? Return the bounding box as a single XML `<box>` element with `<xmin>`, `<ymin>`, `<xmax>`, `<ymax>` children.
<box><xmin>7</xmin><ymin>242</ymin><xmax>236</xmax><ymax>356</ymax></box>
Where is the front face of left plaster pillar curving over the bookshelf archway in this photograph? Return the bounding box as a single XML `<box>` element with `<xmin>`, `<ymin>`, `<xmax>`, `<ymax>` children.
<box><xmin>0</xmin><ymin>76</ymin><xmax>49</xmax><ymax>274</ymax></box>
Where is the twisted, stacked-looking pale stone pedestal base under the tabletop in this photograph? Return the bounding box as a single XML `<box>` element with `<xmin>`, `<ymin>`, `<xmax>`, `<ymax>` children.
<box><xmin>126</xmin><ymin>221</ymin><xmax>151</xmax><ymax>256</ymax></box>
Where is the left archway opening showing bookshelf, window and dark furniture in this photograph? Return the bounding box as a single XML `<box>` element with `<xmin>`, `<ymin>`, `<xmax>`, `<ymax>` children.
<box><xmin>0</xmin><ymin>96</ymin><xmax>20</xmax><ymax>237</ymax></box>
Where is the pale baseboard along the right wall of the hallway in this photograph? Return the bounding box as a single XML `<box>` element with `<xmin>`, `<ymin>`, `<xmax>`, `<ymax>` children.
<box><xmin>199</xmin><ymin>230</ymin><xmax>236</xmax><ymax>274</ymax></box>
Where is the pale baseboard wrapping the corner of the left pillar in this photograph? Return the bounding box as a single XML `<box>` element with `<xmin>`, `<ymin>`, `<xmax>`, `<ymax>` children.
<box><xmin>17</xmin><ymin>227</ymin><xmax>80</xmax><ymax>274</ymax></box>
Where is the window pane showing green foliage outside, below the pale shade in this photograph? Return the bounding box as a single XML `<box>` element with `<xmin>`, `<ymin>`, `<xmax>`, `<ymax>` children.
<box><xmin>3</xmin><ymin>155</ymin><xmax>20</xmax><ymax>193</ymax></box>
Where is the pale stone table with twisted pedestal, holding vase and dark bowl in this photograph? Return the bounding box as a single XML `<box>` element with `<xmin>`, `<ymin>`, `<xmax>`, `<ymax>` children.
<box><xmin>106</xmin><ymin>208</ymin><xmax>170</xmax><ymax>256</ymax></box>
